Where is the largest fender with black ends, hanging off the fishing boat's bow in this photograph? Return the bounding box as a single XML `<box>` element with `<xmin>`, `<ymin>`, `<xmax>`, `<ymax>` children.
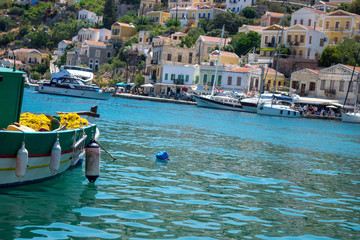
<box><xmin>85</xmin><ymin>140</ymin><xmax>100</xmax><ymax>183</ymax></box>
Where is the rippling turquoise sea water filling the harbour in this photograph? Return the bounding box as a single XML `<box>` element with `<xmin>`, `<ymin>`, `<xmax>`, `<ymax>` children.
<box><xmin>0</xmin><ymin>90</ymin><xmax>360</xmax><ymax>240</ymax></box>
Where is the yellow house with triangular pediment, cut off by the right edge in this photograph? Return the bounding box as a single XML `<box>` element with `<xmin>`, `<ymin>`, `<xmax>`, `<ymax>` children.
<box><xmin>319</xmin><ymin>10</ymin><xmax>360</xmax><ymax>45</ymax></box>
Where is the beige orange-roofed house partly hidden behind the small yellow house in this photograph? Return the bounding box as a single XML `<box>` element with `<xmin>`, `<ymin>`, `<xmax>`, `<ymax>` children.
<box><xmin>195</xmin><ymin>35</ymin><xmax>231</xmax><ymax>64</ymax></box>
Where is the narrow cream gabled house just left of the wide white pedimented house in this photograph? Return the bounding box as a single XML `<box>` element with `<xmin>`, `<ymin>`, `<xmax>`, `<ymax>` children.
<box><xmin>260</xmin><ymin>24</ymin><xmax>287</xmax><ymax>57</ymax></box>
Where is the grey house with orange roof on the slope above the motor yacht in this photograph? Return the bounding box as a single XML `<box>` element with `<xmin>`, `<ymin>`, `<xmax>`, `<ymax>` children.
<box><xmin>66</xmin><ymin>40</ymin><xmax>115</xmax><ymax>71</ymax></box>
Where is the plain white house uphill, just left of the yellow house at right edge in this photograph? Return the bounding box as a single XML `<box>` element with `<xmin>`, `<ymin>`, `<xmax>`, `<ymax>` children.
<box><xmin>290</xmin><ymin>7</ymin><xmax>327</xmax><ymax>30</ymax></box>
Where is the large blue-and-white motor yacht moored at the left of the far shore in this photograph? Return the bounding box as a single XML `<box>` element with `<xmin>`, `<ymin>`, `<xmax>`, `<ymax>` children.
<box><xmin>38</xmin><ymin>75</ymin><xmax>111</xmax><ymax>100</ymax></box>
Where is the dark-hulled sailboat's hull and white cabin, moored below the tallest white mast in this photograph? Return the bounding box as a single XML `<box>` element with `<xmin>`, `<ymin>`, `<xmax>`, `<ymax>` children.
<box><xmin>194</xmin><ymin>95</ymin><xmax>244</xmax><ymax>111</ymax></box>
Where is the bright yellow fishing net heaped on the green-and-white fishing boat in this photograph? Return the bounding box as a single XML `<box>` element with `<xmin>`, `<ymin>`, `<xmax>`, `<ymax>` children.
<box><xmin>20</xmin><ymin>113</ymin><xmax>89</xmax><ymax>131</ymax></box>
